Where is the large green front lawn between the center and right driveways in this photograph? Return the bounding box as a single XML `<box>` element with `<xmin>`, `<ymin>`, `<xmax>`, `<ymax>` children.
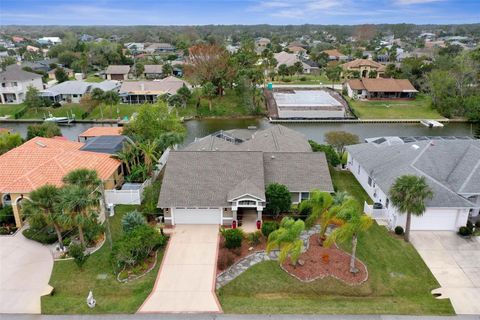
<box><xmin>218</xmin><ymin>172</ymin><xmax>454</xmax><ymax>315</ymax></box>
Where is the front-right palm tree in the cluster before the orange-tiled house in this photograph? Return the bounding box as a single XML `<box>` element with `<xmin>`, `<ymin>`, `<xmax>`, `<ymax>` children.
<box><xmin>61</xmin><ymin>185</ymin><xmax>98</xmax><ymax>247</ymax></box>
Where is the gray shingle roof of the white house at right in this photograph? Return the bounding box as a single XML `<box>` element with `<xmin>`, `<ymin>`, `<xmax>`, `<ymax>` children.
<box><xmin>347</xmin><ymin>140</ymin><xmax>480</xmax><ymax>208</ymax></box>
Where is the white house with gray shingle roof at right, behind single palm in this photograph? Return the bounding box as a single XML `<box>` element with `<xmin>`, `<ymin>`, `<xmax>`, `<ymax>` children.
<box><xmin>346</xmin><ymin>140</ymin><xmax>480</xmax><ymax>231</ymax></box>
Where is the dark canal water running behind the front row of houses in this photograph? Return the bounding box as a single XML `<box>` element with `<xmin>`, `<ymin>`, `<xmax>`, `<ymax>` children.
<box><xmin>0</xmin><ymin>119</ymin><xmax>475</xmax><ymax>144</ymax></box>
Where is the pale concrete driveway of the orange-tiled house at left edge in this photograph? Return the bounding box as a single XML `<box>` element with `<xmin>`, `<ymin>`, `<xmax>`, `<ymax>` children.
<box><xmin>0</xmin><ymin>231</ymin><xmax>53</xmax><ymax>313</ymax></box>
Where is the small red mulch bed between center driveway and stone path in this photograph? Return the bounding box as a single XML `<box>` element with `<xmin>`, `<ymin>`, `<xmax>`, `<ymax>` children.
<box><xmin>217</xmin><ymin>236</ymin><xmax>267</xmax><ymax>274</ymax></box>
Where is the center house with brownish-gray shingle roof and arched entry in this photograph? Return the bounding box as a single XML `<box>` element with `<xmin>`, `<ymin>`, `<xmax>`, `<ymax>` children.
<box><xmin>158</xmin><ymin>126</ymin><xmax>334</xmax><ymax>226</ymax></box>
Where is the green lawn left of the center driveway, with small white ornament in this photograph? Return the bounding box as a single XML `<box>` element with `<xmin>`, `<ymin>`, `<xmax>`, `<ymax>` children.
<box><xmin>42</xmin><ymin>206</ymin><xmax>163</xmax><ymax>314</ymax></box>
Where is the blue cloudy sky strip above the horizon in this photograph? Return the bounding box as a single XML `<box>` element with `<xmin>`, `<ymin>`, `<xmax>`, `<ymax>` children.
<box><xmin>0</xmin><ymin>0</ymin><xmax>480</xmax><ymax>25</ymax></box>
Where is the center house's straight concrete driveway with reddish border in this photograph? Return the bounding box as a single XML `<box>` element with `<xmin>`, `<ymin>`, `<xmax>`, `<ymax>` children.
<box><xmin>138</xmin><ymin>225</ymin><xmax>221</xmax><ymax>312</ymax></box>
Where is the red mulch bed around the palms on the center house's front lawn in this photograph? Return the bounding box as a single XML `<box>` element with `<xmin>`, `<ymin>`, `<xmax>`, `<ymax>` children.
<box><xmin>282</xmin><ymin>234</ymin><xmax>368</xmax><ymax>285</ymax></box>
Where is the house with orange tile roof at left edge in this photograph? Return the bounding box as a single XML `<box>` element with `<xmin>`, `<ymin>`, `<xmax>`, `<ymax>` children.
<box><xmin>0</xmin><ymin>137</ymin><xmax>123</xmax><ymax>227</ymax></box>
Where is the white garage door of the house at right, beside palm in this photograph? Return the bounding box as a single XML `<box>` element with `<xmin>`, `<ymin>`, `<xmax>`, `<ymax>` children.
<box><xmin>411</xmin><ymin>209</ymin><xmax>458</xmax><ymax>231</ymax></box>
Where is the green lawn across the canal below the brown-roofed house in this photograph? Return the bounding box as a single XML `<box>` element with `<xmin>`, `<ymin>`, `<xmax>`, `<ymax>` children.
<box><xmin>347</xmin><ymin>95</ymin><xmax>443</xmax><ymax>119</ymax></box>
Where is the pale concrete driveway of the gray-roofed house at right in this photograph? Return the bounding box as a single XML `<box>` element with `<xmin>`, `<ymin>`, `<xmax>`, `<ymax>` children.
<box><xmin>411</xmin><ymin>231</ymin><xmax>480</xmax><ymax>314</ymax></box>
